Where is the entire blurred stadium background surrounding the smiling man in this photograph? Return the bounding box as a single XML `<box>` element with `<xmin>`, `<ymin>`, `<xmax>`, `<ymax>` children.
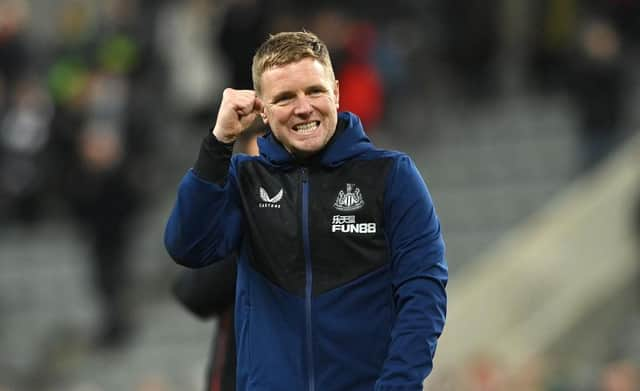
<box><xmin>0</xmin><ymin>0</ymin><xmax>640</xmax><ymax>391</ymax></box>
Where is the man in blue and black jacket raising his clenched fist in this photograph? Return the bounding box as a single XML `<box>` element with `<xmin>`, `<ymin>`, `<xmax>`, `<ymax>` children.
<box><xmin>165</xmin><ymin>32</ymin><xmax>447</xmax><ymax>391</ymax></box>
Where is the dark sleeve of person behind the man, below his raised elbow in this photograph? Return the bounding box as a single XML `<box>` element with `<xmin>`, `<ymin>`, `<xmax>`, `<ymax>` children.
<box><xmin>172</xmin><ymin>256</ymin><xmax>237</xmax><ymax>319</ymax></box>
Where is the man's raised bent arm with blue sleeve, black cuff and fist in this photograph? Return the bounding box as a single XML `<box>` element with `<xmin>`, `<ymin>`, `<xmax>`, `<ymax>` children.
<box><xmin>164</xmin><ymin>88</ymin><xmax>262</xmax><ymax>267</ymax></box>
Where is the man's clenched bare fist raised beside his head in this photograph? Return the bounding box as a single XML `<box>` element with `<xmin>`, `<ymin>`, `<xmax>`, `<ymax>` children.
<box><xmin>213</xmin><ymin>88</ymin><xmax>262</xmax><ymax>144</ymax></box>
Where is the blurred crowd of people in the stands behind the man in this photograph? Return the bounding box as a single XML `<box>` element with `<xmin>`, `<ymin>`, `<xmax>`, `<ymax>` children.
<box><xmin>0</xmin><ymin>0</ymin><xmax>640</xmax><ymax>391</ymax></box>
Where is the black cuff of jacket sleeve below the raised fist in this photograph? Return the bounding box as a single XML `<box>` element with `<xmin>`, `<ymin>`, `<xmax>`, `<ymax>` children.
<box><xmin>193</xmin><ymin>132</ymin><xmax>234</xmax><ymax>186</ymax></box>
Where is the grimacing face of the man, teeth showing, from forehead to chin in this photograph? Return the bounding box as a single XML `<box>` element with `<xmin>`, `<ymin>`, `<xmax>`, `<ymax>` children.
<box><xmin>260</xmin><ymin>58</ymin><xmax>339</xmax><ymax>157</ymax></box>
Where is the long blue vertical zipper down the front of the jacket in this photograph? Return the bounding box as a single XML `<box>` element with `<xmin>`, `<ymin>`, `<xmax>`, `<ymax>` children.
<box><xmin>301</xmin><ymin>167</ymin><xmax>315</xmax><ymax>391</ymax></box>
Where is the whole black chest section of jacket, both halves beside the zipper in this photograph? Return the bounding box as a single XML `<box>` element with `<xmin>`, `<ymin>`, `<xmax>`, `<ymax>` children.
<box><xmin>239</xmin><ymin>159</ymin><xmax>391</xmax><ymax>296</ymax></box>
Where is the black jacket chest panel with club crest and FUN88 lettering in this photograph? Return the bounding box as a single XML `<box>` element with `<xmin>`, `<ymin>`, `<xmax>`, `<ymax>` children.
<box><xmin>309</xmin><ymin>159</ymin><xmax>391</xmax><ymax>295</ymax></box>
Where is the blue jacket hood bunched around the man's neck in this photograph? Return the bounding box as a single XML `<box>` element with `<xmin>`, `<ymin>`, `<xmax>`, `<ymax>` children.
<box><xmin>258</xmin><ymin>112</ymin><xmax>374</xmax><ymax>167</ymax></box>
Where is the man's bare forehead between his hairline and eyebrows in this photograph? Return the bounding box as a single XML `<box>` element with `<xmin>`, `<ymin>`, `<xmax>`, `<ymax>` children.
<box><xmin>260</xmin><ymin>58</ymin><xmax>333</xmax><ymax>96</ymax></box>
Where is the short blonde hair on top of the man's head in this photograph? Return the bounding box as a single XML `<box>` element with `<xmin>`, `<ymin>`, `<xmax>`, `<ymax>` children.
<box><xmin>251</xmin><ymin>31</ymin><xmax>335</xmax><ymax>95</ymax></box>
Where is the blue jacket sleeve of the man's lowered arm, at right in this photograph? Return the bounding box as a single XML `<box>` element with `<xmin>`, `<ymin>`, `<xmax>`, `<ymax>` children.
<box><xmin>375</xmin><ymin>156</ymin><xmax>448</xmax><ymax>391</ymax></box>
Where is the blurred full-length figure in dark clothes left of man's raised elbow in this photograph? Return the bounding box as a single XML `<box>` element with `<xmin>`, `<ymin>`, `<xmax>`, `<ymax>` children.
<box><xmin>65</xmin><ymin>74</ymin><xmax>139</xmax><ymax>346</ymax></box>
